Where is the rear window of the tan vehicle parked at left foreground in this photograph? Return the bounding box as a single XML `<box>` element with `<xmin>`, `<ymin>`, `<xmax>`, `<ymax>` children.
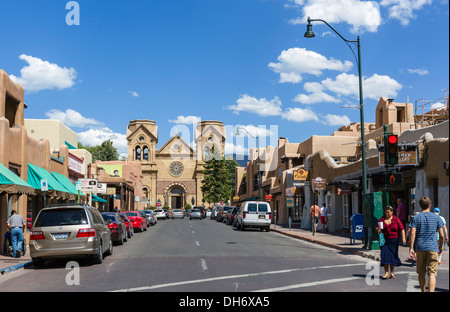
<box><xmin>35</xmin><ymin>208</ymin><xmax>88</xmax><ymax>227</ymax></box>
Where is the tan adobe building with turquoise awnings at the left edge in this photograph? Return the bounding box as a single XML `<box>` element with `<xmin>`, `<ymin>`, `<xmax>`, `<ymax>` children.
<box><xmin>0</xmin><ymin>69</ymin><xmax>75</xmax><ymax>252</ymax></box>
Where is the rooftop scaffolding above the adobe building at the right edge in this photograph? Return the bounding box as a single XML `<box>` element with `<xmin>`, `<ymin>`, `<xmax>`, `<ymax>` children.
<box><xmin>414</xmin><ymin>88</ymin><xmax>449</xmax><ymax>127</ymax></box>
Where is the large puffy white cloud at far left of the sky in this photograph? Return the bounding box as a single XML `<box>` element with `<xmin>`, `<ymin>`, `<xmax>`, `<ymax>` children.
<box><xmin>10</xmin><ymin>54</ymin><xmax>77</xmax><ymax>92</ymax></box>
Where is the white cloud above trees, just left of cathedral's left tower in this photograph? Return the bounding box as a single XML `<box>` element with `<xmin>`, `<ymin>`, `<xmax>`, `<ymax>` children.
<box><xmin>77</xmin><ymin>127</ymin><xmax>128</xmax><ymax>157</ymax></box>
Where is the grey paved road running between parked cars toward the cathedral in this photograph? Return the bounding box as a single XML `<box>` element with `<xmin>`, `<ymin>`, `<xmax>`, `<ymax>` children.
<box><xmin>0</xmin><ymin>219</ymin><xmax>448</xmax><ymax>293</ymax></box>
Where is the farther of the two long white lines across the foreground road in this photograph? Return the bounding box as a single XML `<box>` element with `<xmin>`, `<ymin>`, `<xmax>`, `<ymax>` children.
<box><xmin>112</xmin><ymin>262</ymin><xmax>366</xmax><ymax>292</ymax></box>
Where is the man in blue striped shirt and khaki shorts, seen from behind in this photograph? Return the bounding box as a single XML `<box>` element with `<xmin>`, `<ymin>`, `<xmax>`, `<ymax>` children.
<box><xmin>409</xmin><ymin>196</ymin><xmax>444</xmax><ymax>292</ymax></box>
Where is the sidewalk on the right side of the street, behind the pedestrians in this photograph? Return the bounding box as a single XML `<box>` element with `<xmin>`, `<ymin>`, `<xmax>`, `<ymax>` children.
<box><xmin>270</xmin><ymin>224</ymin><xmax>449</xmax><ymax>270</ymax></box>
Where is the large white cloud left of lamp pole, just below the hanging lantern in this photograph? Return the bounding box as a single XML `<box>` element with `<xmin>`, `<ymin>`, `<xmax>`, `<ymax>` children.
<box><xmin>269</xmin><ymin>48</ymin><xmax>353</xmax><ymax>83</ymax></box>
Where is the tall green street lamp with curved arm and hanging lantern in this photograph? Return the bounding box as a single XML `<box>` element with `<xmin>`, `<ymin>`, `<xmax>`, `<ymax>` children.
<box><xmin>305</xmin><ymin>17</ymin><xmax>367</xmax><ymax>195</ymax></box>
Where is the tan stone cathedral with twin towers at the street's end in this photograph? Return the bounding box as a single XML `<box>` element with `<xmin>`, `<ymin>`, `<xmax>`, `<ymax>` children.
<box><xmin>126</xmin><ymin>119</ymin><xmax>225</xmax><ymax>209</ymax></box>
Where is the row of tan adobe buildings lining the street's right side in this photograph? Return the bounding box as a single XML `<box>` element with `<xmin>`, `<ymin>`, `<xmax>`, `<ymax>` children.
<box><xmin>235</xmin><ymin>97</ymin><xmax>449</xmax><ymax>231</ymax></box>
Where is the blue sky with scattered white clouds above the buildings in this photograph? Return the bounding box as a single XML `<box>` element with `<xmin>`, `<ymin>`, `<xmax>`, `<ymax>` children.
<box><xmin>0</xmin><ymin>0</ymin><xmax>449</xmax><ymax>158</ymax></box>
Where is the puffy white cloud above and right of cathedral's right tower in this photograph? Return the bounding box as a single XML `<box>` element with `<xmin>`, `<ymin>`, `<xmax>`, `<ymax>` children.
<box><xmin>227</xmin><ymin>94</ymin><xmax>281</xmax><ymax>116</ymax></box>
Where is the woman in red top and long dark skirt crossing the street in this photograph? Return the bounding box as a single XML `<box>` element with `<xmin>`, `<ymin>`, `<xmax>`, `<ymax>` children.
<box><xmin>375</xmin><ymin>206</ymin><xmax>406</xmax><ymax>279</ymax></box>
